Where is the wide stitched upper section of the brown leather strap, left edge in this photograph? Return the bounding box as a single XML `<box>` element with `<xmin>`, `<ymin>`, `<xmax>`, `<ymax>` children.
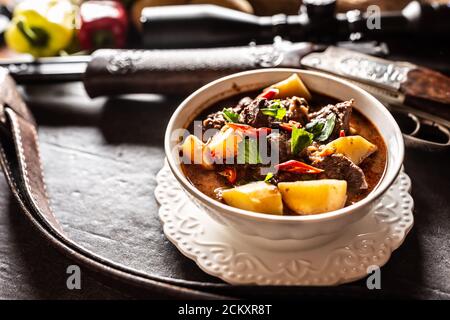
<box><xmin>0</xmin><ymin>70</ymin><xmax>62</xmax><ymax>233</ymax></box>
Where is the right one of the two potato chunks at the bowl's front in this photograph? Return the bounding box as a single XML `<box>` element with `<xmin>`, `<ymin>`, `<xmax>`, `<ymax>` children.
<box><xmin>278</xmin><ymin>179</ymin><xmax>347</xmax><ymax>215</ymax></box>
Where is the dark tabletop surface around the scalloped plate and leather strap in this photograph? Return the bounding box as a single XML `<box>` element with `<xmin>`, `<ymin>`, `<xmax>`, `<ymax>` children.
<box><xmin>0</xmin><ymin>79</ymin><xmax>450</xmax><ymax>299</ymax></box>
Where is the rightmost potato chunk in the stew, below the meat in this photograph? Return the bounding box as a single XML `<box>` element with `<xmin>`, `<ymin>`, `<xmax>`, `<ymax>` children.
<box><xmin>326</xmin><ymin>136</ymin><xmax>377</xmax><ymax>165</ymax></box>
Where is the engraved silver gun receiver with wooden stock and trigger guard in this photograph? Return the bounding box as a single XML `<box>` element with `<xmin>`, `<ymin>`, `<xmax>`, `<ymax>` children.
<box><xmin>301</xmin><ymin>47</ymin><xmax>450</xmax><ymax>149</ymax></box>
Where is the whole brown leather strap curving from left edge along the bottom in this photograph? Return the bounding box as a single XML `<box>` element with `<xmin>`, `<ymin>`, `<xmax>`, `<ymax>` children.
<box><xmin>0</xmin><ymin>68</ymin><xmax>227</xmax><ymax>299</ymax></box>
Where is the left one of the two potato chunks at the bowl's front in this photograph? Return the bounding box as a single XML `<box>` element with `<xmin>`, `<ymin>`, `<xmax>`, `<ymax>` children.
<box><xmin>222</xmin><ymin>181</ymin><xmax>283</xmax><ymax>215</ymax></box>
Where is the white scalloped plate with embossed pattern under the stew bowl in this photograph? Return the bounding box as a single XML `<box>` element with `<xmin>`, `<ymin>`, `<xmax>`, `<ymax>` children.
<box><xmin>155</xmin><ymin>164</ymin><xmax>414</xmax><ymax>286</ymax></box>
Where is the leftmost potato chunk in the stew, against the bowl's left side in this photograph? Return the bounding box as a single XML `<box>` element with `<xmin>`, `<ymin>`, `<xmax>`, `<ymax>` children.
<box><xmin>181</xmin><ymin>134</ymin><xmax>214</xmax><ymax>170</ymax></box>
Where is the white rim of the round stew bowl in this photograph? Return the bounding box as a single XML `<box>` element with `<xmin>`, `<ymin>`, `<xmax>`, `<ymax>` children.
<box><xmin>164</xmin><ymin>68</ymin><xmax>404</xmax><ymax>223</ymax></box>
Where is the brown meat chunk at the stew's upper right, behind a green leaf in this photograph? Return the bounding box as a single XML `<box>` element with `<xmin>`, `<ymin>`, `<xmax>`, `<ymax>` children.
<box><xmin>309</xmin><ymin>99</ymin><xmax>354</xmax><ymax>141</ymax></box>
